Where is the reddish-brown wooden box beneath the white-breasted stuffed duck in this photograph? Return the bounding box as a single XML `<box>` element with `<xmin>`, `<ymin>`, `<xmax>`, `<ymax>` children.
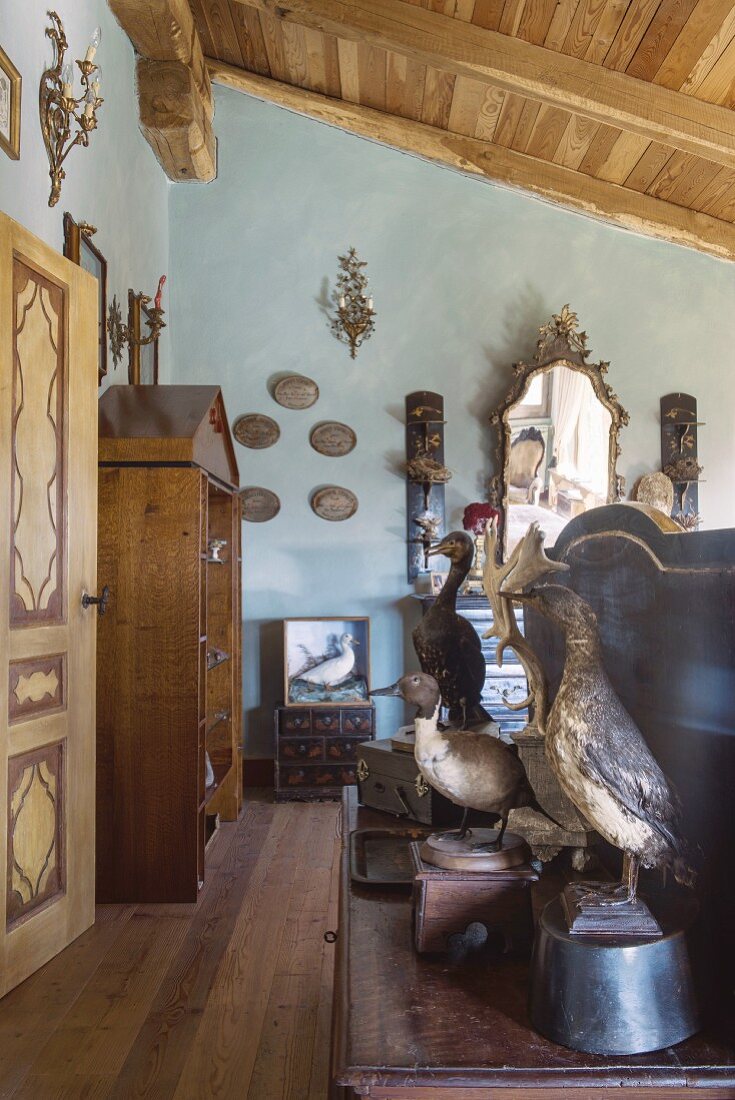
<box><xmin>410</xmin><ymin>842</ymin><xmax>538</xmax><ymax>954</ymax></box>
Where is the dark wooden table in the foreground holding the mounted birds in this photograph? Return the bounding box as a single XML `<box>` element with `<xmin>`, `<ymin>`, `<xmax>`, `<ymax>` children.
<box><xmin>332</xmin><ymin>789</ymin><xmax>735</xmax><ymax>1100</ymax></box>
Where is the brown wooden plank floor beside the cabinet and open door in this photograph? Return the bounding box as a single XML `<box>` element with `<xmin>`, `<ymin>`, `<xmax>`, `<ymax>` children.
<box><xmin>0</xmin><ymin>792</ymin><xmax>339</xmax><ymax>1100</ymax></box>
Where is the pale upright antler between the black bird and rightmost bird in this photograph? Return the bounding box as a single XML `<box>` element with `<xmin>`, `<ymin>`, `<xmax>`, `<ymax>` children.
<box><xmin>482</xmin><ymin>517</ymin><xmax>569</xmax><ymax>734</ymax></box>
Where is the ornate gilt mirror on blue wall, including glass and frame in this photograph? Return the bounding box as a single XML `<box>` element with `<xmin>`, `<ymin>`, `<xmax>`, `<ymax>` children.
<box><xmin>490</xmin><ymin>306</ymin><xmax>628</xmax><ymax>558</ymax></box>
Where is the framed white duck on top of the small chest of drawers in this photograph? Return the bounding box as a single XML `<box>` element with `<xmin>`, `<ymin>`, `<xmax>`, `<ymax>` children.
<box><xmin>283</xmin><ymin>616</ymin><xmax>370</xmax><ymax>706</ymax></box>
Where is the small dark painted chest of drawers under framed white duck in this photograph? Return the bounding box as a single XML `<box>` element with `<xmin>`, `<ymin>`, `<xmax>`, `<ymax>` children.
<box><xmin>275</xmin><ymin>704</ymin><xmax>375</xmax><ymax>802</ymax></box>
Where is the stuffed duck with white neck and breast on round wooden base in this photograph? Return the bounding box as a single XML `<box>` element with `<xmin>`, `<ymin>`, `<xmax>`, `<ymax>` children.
<box><xmin>370</xmin><ymin>672</ymin><xmax>558</xmax><ymax>850</ymax></box>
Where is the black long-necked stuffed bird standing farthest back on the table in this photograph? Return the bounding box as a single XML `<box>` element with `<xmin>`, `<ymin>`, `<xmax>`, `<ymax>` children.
<box><xmin>413</xmin><ymin>531</ymin><xmax>490</xmax><ymax>729</ymax></box>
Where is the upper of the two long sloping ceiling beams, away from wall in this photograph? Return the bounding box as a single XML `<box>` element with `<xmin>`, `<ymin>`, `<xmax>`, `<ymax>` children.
<box><xmin>231</xmin><ymin>0</ymin><xmax>735</xmax><ymax>168</ymax></box>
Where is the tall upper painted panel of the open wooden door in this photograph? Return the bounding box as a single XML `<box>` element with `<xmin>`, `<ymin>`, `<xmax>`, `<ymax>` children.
<box><xmin>10</xmin><ymin>256</ymin><xmax>66</xmax><ymax>627</ymax></box>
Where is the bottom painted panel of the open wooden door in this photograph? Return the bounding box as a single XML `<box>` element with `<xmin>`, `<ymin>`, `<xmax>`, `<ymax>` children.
<box><xmin>6</xmin><ymin>741</ymin><xmax>65</xmax><ymax>927</ymax></box>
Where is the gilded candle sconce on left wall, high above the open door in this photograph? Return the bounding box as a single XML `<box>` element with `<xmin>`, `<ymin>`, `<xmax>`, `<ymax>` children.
<box><xmin>39</xmin><ymin>11</ymin><xmax>103</xmax><ymax>206</ymax></box>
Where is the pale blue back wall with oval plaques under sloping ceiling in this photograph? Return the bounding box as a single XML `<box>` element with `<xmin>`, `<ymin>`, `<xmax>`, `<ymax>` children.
<box><xmin>171</xmin><ymin>90</ymin><xmax>735</xmax><ymax>755</ymax></box>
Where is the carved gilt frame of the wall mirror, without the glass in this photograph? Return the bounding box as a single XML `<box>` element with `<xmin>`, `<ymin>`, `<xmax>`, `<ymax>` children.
<box><xmin>487</xmin><ymin>305</ymin><xmax>630</xmax><ymax>556</ymax></box>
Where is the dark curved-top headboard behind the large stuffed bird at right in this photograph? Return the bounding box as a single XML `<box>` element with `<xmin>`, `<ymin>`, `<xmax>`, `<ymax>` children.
<box><xmin>527</xmin><ymin>504</ymin><xmax>735</xmax><ymax>994</ymax></box>
